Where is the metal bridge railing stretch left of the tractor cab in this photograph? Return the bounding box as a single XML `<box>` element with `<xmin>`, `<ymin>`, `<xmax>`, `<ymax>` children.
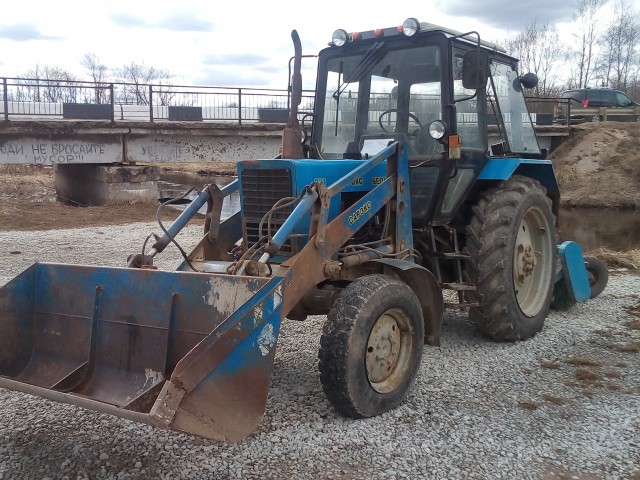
<box><xmin>1</xmin><ymin>77</ymin><xmax>314</xmax><ymax>124</ymax></box>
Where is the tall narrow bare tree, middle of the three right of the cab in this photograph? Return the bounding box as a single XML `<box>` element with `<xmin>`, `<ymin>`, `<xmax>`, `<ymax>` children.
<box><xmin>569</xmin><ymin>0</ymin><xmax>608</xmax><ymax>88</ymax></box>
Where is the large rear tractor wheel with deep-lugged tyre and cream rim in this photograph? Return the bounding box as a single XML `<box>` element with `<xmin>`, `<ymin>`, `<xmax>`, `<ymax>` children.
<box><xmin>466</xmin><ymin>176</ymin><xmax>557</xmax><ymax>341</ymax></box>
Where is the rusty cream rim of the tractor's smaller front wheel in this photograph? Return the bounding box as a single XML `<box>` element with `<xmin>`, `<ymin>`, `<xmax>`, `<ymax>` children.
<box><xmin>365</xmin><ymin>308</ymin><xmax>415</xmax><ymax>393</ymax></box>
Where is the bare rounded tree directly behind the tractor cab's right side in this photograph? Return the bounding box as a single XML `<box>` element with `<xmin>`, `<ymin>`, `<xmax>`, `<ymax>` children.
<box><xmin>507</xmin><ymin>20</ymin><xmax>565</xmax><ymax>97</ymax></box>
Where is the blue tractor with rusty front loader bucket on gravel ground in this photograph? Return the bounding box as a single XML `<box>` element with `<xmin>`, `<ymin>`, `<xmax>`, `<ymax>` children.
<box><xmin>0</xmin><ymin>18</ymin><xmax>606</xmax><ymax>441</ymax></box>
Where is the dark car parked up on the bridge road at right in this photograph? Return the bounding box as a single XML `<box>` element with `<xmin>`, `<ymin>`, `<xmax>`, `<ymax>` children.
<box><xmin>556</xmin><ymin>88</ymin><xmax>639</xmax><ymax>123</ymax></box>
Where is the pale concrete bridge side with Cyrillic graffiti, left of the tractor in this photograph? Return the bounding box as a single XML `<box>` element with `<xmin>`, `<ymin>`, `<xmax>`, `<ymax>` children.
<box><xmin>0</xmin><ymin>121</ymin><xmax>283</xmax><ymax>165</ymax></box>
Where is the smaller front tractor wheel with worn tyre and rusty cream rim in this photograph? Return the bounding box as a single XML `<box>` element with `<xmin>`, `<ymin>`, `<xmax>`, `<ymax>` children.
<box><xmin>318</xmin><ymin>275</ymin><xmax>424</xmax><ymax>418</ymax></box>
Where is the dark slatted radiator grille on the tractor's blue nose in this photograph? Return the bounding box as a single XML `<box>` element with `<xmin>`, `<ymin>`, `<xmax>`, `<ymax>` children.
<box><xmin>241</xmin><ymin>168</ymin><xmax>292</xmax><ymax>256</ymax></box>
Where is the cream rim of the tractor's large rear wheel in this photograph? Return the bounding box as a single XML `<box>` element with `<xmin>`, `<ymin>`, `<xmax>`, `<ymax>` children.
<box><xmin>513</xmin><ymin>206</ymin><xmax>554</xmax><ymax>317</ymax></box>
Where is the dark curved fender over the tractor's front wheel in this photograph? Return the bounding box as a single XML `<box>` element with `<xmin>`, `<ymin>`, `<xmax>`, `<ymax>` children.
<box><xmin>371</xmin><ymin>258</ymin><xmax>444</xmax><ymax>347</ymax></box>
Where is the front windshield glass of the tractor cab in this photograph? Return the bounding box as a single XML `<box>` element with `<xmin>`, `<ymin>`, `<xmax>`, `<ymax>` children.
<box><xmin>320</xmin><ymin>42</ymin><xmax>446</xmax><ymax>158</ymax></box>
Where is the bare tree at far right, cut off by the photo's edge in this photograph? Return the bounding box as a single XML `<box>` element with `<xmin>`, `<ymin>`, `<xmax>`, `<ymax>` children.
<box><xmin>602</xmin><ymin>0</ymin><xmax>640</xmax><ymax>89</ymax></box>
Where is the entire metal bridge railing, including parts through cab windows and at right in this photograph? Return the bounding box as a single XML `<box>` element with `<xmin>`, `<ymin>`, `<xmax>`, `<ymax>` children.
<box><xmin>6</xmin><ymin>77</ymin><xmax>640</xmax><ymax>125</ymax></box>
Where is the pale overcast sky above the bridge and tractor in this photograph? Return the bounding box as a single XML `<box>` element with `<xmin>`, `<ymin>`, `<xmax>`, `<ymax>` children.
<box><xmin>0</xmin><ymin>0</ymin><xmax>640</xmax><ymax>88</ymax></box>
